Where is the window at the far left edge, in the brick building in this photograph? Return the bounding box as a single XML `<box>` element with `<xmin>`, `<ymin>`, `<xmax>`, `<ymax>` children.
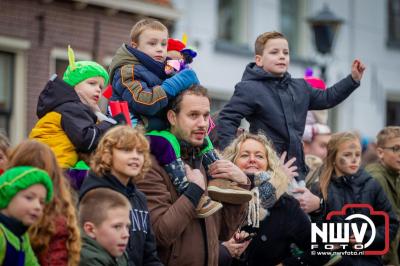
<box><xmin>0</xmin><ymin>51</ymin><xmax>15</xmax><ymax>135</ymax></box>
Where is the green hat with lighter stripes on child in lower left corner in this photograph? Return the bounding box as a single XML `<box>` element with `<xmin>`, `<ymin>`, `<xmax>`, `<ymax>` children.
<box><xmin>0</xmin><ymin>166</ymin><xmax>53</xmax><ymax>210</ymax></box>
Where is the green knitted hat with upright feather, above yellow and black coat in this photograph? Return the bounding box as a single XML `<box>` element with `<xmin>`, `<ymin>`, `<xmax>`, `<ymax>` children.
<box><xmin>63</xmin><ymin>46</ymin><xmax>109</xmax><ymax>87</ymax></box>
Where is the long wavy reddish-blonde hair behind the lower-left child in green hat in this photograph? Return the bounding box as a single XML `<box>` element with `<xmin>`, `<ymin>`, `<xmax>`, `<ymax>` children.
<box><xmin>8</xmin><ymin>140</ymin><xmax>81</xmax><ymax>266</ymax></box>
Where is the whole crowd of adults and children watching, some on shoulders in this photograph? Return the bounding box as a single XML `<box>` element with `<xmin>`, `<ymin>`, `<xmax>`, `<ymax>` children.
<box><xmin>0</xmin><ymin>19</ymin><xmax>400</xmax><ymax>266</ymax></box>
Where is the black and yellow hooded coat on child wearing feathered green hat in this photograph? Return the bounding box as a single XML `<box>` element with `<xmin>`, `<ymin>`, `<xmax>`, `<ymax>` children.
<box><xmin>29</xmin><ymin>78</ymin><xmax>113</xmax><ymax>168</ymax></box>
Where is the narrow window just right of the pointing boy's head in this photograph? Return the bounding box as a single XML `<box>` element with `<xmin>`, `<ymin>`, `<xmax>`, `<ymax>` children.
<box><xmin>280</xmin><ymin>0</ymin><xmax>301</xmax><ymax>57</ymax></box>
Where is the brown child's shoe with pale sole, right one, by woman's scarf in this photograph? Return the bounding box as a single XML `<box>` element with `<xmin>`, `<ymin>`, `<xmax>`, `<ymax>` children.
<box><xmin>207</xmin><ymin>178</ymin><xmax>253</xmax><ymax>205</ymax></box>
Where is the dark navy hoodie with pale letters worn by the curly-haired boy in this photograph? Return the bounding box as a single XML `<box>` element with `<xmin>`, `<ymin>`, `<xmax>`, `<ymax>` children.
<box><xmin>79</xmin><ymin>172</ymin><xmax>163</xmax><ymax>266</ymax></box>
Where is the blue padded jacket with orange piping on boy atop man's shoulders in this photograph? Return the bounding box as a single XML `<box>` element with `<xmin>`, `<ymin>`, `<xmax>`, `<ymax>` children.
<box><xmin>110</xmin><ymin>44</ymin><xmax>168</xmax><ymax>130</ymax></box>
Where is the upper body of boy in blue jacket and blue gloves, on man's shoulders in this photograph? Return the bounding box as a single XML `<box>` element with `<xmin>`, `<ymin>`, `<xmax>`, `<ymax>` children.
<box><xmin>110</xmin><ymin>19</ymin><xmax>199</xmax><ymax>130</ymax></box>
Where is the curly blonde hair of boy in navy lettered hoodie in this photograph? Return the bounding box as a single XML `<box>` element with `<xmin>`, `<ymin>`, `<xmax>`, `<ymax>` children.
<box><xmin>90</xmin><ymin>126</ymin><xmax>151</xmax><ymax>181</ymax></box>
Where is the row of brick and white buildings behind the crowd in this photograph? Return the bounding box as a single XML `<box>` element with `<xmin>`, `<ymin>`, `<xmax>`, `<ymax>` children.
<box><xmin>0</xmin><ymin>0</ymin><xmax>400</xmax><ymax>143</ymax></box>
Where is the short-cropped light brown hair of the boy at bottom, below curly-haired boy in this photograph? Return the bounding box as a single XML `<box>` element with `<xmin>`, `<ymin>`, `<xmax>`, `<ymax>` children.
<box><xmin>79</xmin><ymin>188</ymin><xmax>131</xmax><ymax>228</ymax></box>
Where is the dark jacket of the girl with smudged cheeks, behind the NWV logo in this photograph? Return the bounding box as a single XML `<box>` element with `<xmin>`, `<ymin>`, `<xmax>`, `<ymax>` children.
<box><xmin>311</xmin><ymin>169</ymin><xmax>399</xmax><ymax>266</ymax></box>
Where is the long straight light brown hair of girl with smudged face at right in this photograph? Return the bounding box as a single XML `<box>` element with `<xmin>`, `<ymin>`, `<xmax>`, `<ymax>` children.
<box><xmin>319</xmin><ymin>132</ymin><xmax>360</xmax><ymax>200</ymax></box>
